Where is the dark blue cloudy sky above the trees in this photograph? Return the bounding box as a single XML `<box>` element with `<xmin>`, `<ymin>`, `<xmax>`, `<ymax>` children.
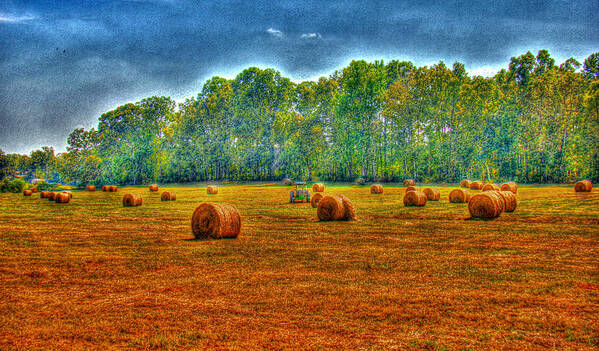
<box><xmin>0</xmin><ymin>0</ymin><xmax>599</xmax><ymax>153</ymax></box>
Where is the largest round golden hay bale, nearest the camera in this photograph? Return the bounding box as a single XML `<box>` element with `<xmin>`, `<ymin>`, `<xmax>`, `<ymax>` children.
<box><xmin>191</xmin><ymin>202</ymin><xmax>241</xmax><ymax>239</ymax></box>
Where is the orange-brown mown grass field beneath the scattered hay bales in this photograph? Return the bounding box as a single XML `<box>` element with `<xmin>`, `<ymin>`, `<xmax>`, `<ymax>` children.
<box><xmin>0</xmin><ymin>184</ymin><xmax>599</xmax><ymax>350</ymax></box>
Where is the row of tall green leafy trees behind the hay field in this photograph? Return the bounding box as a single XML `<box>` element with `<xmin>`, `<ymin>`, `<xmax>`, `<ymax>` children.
<box><xmin>0</xmin><ymin>50</ymin><xmax>599</xmax><ymax>184</ymax></box>
